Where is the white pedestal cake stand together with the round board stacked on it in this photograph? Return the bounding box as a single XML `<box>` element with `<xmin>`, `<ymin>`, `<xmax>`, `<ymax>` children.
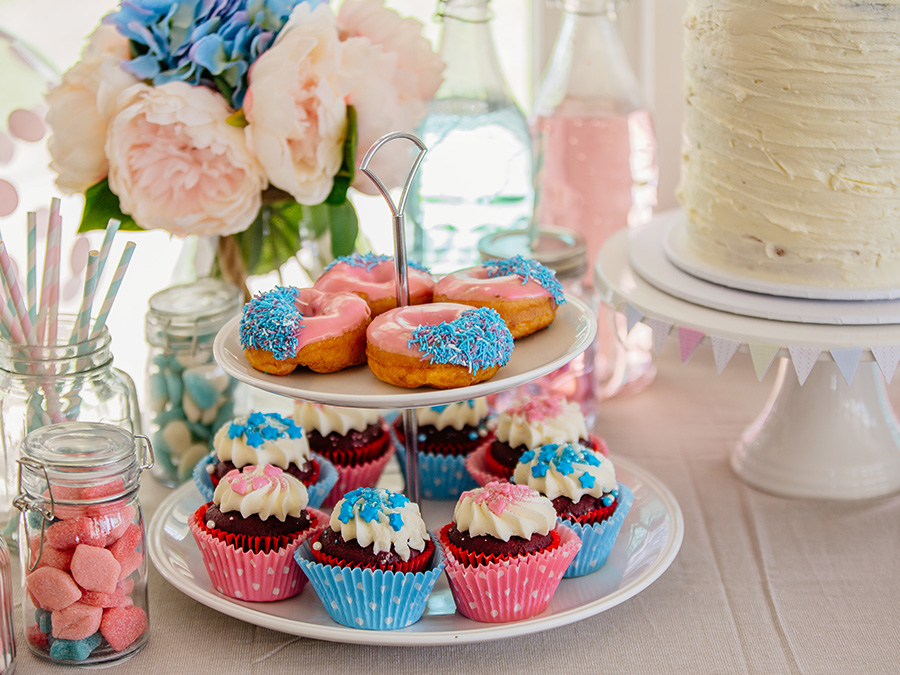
<box><xmin>596</xmin><ymin>211</ymin><xmax>900</xmax><ymax>500</ymax></box>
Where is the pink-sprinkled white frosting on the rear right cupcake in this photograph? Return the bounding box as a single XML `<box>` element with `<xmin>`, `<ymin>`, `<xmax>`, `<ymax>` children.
<box><xmin>496</xmin><ymin>396</ymin><xmax>588</xmax><ymax>450</ymax></box>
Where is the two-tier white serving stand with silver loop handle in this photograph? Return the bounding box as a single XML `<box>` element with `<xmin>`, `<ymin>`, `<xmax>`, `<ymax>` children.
<box><xmin>148</xmin><ymin>134</ymin><xmax>684</xmax><ymax>646</ymax></box>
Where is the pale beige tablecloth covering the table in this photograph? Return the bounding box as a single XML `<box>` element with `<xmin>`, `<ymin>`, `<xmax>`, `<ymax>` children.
<box><xmin>8</xmin><ymin>339</ymin><xmax>900</xmax><ymax>675</ymax></box>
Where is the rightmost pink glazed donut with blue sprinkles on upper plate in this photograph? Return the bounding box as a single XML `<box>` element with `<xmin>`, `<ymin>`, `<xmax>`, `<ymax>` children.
<box><xmin>434</xmin><ymin>255</ymin><xmax>566</xmax><ymax>339</ymax></box>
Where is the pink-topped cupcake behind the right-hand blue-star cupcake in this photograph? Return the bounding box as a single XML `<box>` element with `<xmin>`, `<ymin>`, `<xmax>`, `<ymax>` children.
<box><xmin>466</xmin><ymin>394</ymin><xmax>607</xmax><ymax>485</ymax></box>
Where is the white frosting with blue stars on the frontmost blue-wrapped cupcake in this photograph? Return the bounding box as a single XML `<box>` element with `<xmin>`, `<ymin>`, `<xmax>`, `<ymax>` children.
<box><xmin>331</xmin><ymin>488</ymin><xmax>431</xmax><ymax>560</ymax></box>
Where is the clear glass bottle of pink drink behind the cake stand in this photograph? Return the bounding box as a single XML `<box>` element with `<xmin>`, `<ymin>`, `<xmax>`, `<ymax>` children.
<box><xmin>532</xmin><ymin>0</ymin><xmax>658</xmax><ymax>397</ymax></box>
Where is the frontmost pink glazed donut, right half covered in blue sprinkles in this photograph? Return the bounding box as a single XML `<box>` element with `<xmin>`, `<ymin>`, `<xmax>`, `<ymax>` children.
<box><xmin>366</xmin><ymin>302</ymin><xmax>513</xmax><ymax>389</ymax></box>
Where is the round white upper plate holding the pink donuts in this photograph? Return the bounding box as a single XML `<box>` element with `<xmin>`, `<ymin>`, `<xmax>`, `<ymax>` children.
<box><xmin>213</xmin><ymin>297</ymin><xmax>597</xmax><ymax>409</ymax></box>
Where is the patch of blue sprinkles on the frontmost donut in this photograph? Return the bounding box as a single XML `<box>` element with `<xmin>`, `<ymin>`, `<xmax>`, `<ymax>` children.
<box><xmin>408</xmin><ymin>307</ymin><xmax>513</xmax><ymax>373</ymax></box>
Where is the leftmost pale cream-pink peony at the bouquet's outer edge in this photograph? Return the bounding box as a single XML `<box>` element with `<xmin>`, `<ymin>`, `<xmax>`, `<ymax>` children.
<box><xmin>47</xmin><ymin>26</ymin><xmax>137</xmax><ymax>194</ymax></box>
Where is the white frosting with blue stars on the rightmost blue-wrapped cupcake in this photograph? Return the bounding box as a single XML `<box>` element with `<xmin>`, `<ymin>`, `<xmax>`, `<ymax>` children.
<box><xmin>513</xmin><ymin>443</ymin><xmax>618</xmax><ymax>503</ymax></box>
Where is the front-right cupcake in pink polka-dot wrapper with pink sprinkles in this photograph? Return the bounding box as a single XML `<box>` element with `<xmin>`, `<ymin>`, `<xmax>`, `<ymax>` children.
<box><xmin>439</xmin><ymin>482</ymin><xmax>581</xmax><ymax>623</ymax></box>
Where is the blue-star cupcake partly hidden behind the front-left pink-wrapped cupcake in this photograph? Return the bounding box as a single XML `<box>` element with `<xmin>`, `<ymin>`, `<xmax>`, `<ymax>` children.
<box><xmin>194</xmin><ymin>412</ymin><xmax>337</xmax><ymax>506</ymax></box>
